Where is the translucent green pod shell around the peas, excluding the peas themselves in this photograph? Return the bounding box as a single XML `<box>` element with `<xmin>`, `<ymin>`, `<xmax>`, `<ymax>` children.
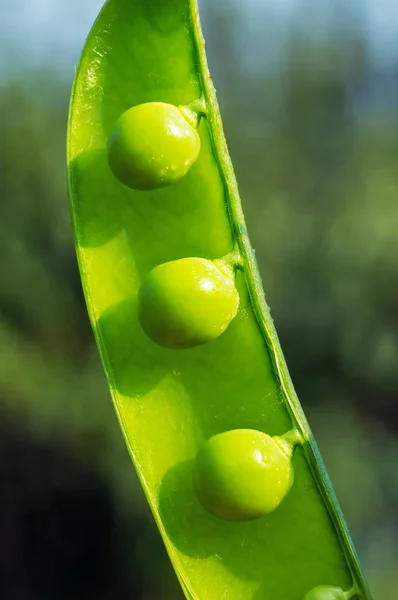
<box><xmin>68</xmin><ymin>0</ymin><xmax>370</xmax><ymax>600</ymax></box>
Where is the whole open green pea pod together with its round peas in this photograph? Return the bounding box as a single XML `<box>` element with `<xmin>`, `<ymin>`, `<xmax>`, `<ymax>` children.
<box><xmin>68</xmin><ymin>0</ymin><xmax>370</xmax><ymax>600</ymax></box>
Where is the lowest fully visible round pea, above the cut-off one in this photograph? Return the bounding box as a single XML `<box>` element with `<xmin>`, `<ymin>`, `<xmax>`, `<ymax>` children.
<box><xmin>195</xmin><ymin>429</ymin><xmax>293</xmax><ymax>521</ymax></box>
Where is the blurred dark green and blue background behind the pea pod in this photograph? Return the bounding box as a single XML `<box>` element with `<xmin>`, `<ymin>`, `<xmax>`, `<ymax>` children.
<box><xmin>0</xmin><ymin>0</ymin><xmax>398</xmax><ymax>600</ymax></box>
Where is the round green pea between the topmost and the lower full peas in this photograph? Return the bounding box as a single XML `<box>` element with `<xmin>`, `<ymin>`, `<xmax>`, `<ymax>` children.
<box><xmin>139</xmin><ymin>258</ymin><xmax>239</xmax><ymax>348</ymax></box>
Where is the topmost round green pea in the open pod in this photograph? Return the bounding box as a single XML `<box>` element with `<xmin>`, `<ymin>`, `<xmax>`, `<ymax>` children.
<box><xmin>108</xmin><ymin>102</ymin><xmax>200</xmax><ymax>190</ymax></box>
